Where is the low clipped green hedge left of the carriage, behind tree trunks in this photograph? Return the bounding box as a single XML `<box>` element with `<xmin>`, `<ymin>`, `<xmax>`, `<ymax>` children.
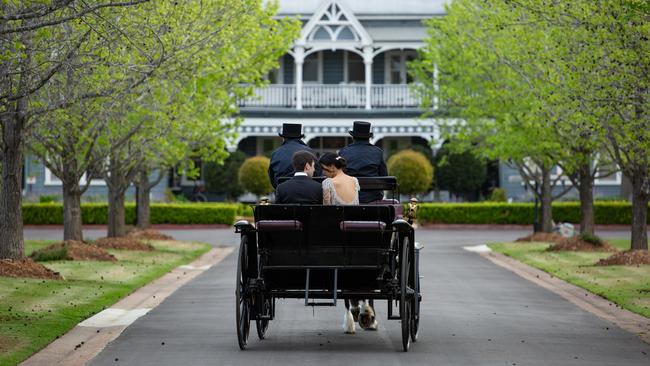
<box><xmin>23</xmin><ymin>203</ymin><xmax>240</xmax><ymax>225</ymax></box>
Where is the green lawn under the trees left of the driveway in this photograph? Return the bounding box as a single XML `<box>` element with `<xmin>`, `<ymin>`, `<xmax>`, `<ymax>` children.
<box><xmin>0</xmin><ymin>241</ymin><xmax>210</xmax><ymax>365</ymax></box>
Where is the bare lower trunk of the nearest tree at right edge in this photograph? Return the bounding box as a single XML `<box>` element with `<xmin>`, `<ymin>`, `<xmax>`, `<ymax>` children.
<box><xmin>630</xmin><ymin>170</ymin><xmax>650</xmax><ymax>250</ymax></box>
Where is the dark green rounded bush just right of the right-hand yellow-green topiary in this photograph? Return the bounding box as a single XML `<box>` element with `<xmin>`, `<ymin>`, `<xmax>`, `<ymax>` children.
<box><xmin>435</xmin><ymin>145</ymin><xmax>487</xmax><ymax>199</ymax></box>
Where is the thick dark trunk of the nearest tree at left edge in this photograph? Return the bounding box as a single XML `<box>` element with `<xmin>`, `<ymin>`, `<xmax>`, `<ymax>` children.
<box><xmin>0</xmin><ymin>113</ymin><xmax>25</xmax><ymax>259</ymax></box>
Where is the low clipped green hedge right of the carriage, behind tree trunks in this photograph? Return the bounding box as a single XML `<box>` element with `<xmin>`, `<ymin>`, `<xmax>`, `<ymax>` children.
<box><xmin>418</xmin><ymin>202</ymin><xmax>650</xmax><ymax>225</ymax></box>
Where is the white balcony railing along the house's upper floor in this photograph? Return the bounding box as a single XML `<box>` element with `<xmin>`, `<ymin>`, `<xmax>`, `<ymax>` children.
<box><xmin>239</xmin><ymin>84</ymin><xmax>419</xmax><ymax>110</ymax></box>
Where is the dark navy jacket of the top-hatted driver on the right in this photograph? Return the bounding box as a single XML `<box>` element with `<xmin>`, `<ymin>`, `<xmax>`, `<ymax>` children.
<box><xmin>339</xmin><ymin>141</ymin><xmax>388</xmax><ymax>203</ymax></box>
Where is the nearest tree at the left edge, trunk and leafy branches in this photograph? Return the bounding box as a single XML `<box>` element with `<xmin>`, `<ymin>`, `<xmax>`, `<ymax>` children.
<box><xmin>0</xmin><ymin>0</ymin><xmax>147</xmax><ymax>258</ymax></box>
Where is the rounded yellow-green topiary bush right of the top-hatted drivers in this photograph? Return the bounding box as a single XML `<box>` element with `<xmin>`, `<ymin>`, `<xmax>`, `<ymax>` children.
<box><xmin>386</xmin><ymin>150</ymin><xmax>433</xmax><ymax>195</ymax></box>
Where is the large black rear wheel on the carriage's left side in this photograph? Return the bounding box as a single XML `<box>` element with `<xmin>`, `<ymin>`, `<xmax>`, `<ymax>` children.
<box><xmin>235</xmin><ymin>236</ymin><xmax>251</xmax><ymax>350</ymax></box>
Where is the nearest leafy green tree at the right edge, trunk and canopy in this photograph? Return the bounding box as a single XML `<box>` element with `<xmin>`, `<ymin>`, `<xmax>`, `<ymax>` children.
<box><xmin>496</xmin><ymin>0</ymin><xmax>650</xmax><ymax>250</ymax></box>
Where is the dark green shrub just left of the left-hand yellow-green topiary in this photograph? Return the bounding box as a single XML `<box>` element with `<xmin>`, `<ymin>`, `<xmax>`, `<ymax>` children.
<box><xmin>203</xmin><ymin>151</ymin><xmax>246</xmax><ymax>201</ymax></box>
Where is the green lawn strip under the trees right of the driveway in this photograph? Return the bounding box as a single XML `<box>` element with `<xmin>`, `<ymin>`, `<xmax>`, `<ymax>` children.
<box><xmin>489</xmin><ymin>239</ymin><xmax>650</xmax><ymax>318</ymax></box>
